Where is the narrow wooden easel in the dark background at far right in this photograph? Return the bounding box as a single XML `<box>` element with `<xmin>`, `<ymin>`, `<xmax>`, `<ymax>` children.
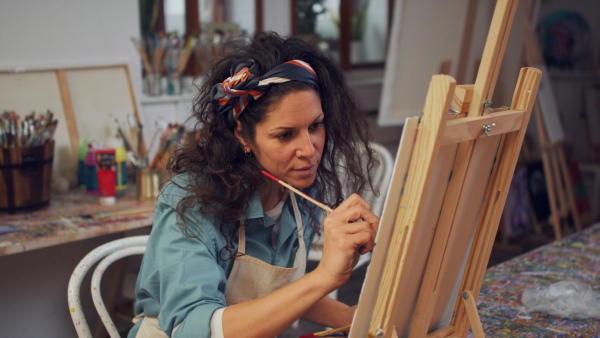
<box><xmin>524</xmin><ymin>1</ymin><xmax>582</xmax><ymax>239</ymax></box>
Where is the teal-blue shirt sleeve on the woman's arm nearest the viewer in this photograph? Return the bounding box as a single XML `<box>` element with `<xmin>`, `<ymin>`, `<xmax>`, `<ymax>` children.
<box><xmin>136</xmin><ymin>186</ymin><xmax>227</xmax><ymax>338</ymax></box>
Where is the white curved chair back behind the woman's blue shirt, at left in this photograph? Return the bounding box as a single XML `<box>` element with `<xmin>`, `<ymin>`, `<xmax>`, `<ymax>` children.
<box><xmin>67</xmin><ymin>235</ymin><xmax>148</xmax><ymax>338</ymax></box>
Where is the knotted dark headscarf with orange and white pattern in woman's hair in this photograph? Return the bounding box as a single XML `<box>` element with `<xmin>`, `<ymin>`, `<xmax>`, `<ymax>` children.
<box><xmin>212</xmin><ymin>59</ymin><xmax>318</xmax><ymax>123</ymax></box>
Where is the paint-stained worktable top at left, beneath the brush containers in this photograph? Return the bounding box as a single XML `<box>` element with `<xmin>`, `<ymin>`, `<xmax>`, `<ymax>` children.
<box><xmin>0</xmin><ymin>190</ymin><xmax>154</xmax><ymax>256</ymax></box>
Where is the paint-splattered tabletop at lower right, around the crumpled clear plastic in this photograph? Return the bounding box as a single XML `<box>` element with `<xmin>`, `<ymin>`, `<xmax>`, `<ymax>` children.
<box><xmin>477</xmin><ymin>223</ymin><xmax>600</xmax><ymax>338</ymax></box>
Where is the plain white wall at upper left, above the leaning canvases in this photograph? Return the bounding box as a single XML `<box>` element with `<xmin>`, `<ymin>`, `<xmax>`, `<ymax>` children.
<box><xmin>0</xmin><ymin>0</ymin><xmax>141</xmax><ymax>115</ymax></box>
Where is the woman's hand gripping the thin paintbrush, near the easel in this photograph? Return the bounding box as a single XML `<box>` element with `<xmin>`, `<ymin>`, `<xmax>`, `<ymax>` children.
<box><xmin>315</xmin><ymin>194</ymin><xmax>379</xmax><ymax>289</ymax></box>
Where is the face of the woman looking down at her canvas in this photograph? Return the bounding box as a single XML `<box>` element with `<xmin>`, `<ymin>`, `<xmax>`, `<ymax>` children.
<box><xmin>236</xmin><ymin>90</ymin><xmax>325</xmax><ymax>188</ymax></box>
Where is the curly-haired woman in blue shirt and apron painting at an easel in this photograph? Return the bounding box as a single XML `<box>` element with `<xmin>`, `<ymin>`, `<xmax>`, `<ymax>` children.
<box><xmin>130</xmin><ymin>33</ymin><xmax>379</xmax><ymax>337</ymax></box>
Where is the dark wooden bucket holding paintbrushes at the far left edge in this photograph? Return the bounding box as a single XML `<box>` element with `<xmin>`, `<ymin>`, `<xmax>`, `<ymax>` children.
<box><xmin>0</xmin><ymin>141</ymin><xmax>54</xmax><ymax>213</ymax></box>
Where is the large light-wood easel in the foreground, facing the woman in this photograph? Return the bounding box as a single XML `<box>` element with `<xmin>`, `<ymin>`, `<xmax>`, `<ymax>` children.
<box><xmin>350</xmin><ymin>0</ymin><xmax>541</xmax><ymax>338</ymax></box>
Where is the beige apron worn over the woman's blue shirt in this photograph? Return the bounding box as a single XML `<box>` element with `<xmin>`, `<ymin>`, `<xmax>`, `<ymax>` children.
<box><xmin>133</xmin><ymin>192</ymin><xmax>306</xmax><ymax>338</ymax></box>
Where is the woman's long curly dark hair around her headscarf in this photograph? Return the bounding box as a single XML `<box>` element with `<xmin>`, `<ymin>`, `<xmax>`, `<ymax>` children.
<box><xmin>167</xmin><ymin>33</ymin><xmax>377</xmax><ymax>259</ymax></box>
